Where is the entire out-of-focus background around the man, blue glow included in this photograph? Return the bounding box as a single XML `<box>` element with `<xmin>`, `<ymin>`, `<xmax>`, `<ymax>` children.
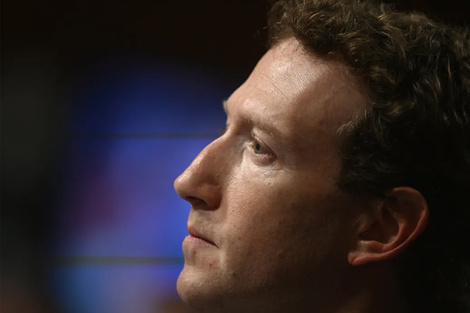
<box><xmin>0</xmin><ymin>0</ymin><xmax>470</xmax><ymax>313</ymax></box>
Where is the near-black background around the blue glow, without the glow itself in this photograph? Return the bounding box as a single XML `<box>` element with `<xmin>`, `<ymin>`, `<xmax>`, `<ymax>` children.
<box><xmin>0</xmin><ymin>0</ymin><xmax>470</xmax><ymax>313</ymax></box>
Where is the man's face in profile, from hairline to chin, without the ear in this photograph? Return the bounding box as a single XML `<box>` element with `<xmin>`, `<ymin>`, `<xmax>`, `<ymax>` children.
<box><xmin>175</xmin><ymin>39</ymin><xmax>365</xmax><ymax>312</ymax></box>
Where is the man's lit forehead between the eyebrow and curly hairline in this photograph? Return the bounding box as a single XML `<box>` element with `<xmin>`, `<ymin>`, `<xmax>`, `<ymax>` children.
<box><xmin>225</xmin><ymin>39</ymin><xmax>366</xmax><ymax>146</ymax></box>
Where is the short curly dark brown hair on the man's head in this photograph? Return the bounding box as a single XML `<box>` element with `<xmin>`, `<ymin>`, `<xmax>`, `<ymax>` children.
<box><xmin>268</xmin><ymin>0</ymin><xmax>470</xmax><ymax>313</ymax></box>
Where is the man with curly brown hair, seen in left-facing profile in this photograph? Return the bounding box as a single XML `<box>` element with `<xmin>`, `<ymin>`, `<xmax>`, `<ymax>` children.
<box><xmin>175</xmin><ymin>0</ymin><xmax>470</xmax><ymax>313</ymax></box>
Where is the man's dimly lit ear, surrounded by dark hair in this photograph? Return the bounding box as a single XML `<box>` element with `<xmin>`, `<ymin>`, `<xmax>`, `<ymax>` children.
<box><xmin>348</xmin><ymin>187</ymin><xmax>429</xmax><ymax>265</ymax></box>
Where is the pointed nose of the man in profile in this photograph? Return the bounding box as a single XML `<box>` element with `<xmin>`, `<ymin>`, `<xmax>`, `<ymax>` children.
<box><xmin>174</xmin><ymin>138</ymin><xmax>228</xmax><ymax>210</ymax></box>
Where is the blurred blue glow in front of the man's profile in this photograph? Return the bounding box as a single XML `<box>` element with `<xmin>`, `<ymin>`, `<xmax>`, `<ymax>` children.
<box><xmin>52</xmin><ymin>52</ymin><xmax>241</xmax><ymax>313</ymax></box>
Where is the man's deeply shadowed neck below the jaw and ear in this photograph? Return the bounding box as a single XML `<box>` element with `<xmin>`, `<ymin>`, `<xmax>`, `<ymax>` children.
<box><xmin>195</xmin><ymin>262</ymin><xmax>407</xmax><ymax>313</ymax></box>
